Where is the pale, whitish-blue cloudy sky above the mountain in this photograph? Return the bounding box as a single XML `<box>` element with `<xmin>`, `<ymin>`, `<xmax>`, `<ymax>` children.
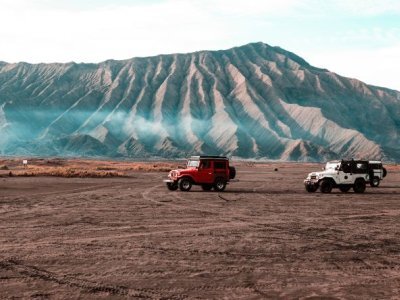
<box><xmin>0</xmin><ymin>0</ymin><xmax>400</xmax><ymax>90</ymax></box>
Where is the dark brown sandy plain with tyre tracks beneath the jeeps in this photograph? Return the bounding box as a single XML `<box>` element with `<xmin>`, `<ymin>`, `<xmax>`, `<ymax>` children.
<box><xmin>0</xmin><ymin>164</ymin><xmax>400</xmax><ymax>299</ymax></box>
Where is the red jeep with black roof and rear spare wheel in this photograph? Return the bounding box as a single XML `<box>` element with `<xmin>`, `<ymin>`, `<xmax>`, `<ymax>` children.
<box><xmin>164</xmin><ymin>156</ymin><xmax>236</xmax><ymax>192</ymax></box>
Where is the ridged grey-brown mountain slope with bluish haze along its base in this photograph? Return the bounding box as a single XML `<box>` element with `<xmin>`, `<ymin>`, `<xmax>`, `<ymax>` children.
<box><xmin>0</xmin><ymin>43</ymin><xmax>400</xmax><ymax>161</ymax></box>
